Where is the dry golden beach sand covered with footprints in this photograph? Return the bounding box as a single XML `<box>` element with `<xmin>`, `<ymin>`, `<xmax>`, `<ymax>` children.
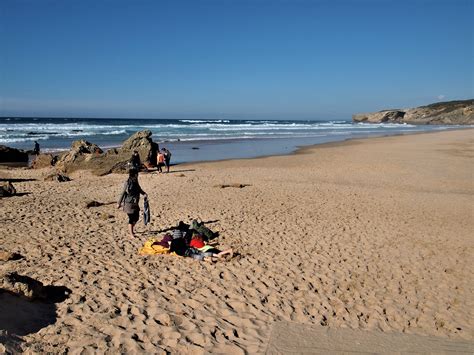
<box><xmin>0</xmin><ymin>130</ymin><xmax>474</xmax><ymax>353</ymax></box>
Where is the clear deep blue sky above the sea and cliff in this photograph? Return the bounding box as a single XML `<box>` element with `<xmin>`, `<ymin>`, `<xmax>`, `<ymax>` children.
<box><xmin>0</xmin><ymin>0</ymin><xmax>474</xmax><ymax>120</ymax></box>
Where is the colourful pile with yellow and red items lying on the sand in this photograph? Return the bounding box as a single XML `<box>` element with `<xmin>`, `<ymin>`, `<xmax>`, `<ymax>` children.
<box><xmin>138</xmin><ymin>219</ymin><xmax>233</xmax><ymax>261</ymax></box>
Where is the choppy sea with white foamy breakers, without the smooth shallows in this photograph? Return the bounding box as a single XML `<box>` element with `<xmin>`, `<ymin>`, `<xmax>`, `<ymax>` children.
<box><xmin>0</xmin><ymin>118</ymin><xmax>460</xmax><ymax>151</ymax></box>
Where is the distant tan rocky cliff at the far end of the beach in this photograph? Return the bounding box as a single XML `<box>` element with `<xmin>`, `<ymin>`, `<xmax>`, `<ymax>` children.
<box><xmin>352</xmin><ymin>99</ymin><xmax>474</xmax><ymax>125</ymax></box>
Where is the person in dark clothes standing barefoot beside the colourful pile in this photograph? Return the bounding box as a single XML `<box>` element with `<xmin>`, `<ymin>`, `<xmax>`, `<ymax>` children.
<box><xmin>117</xmin><ymin>168</ymin><xmax>147</xmax><ymax>237</ymax></box>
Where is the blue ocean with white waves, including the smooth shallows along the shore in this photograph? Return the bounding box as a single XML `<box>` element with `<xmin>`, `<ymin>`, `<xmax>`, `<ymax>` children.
<box><xmin>0</xmin><ymin>117</ymin><xmax>465</xmax><ymax>163</ymax></box>
